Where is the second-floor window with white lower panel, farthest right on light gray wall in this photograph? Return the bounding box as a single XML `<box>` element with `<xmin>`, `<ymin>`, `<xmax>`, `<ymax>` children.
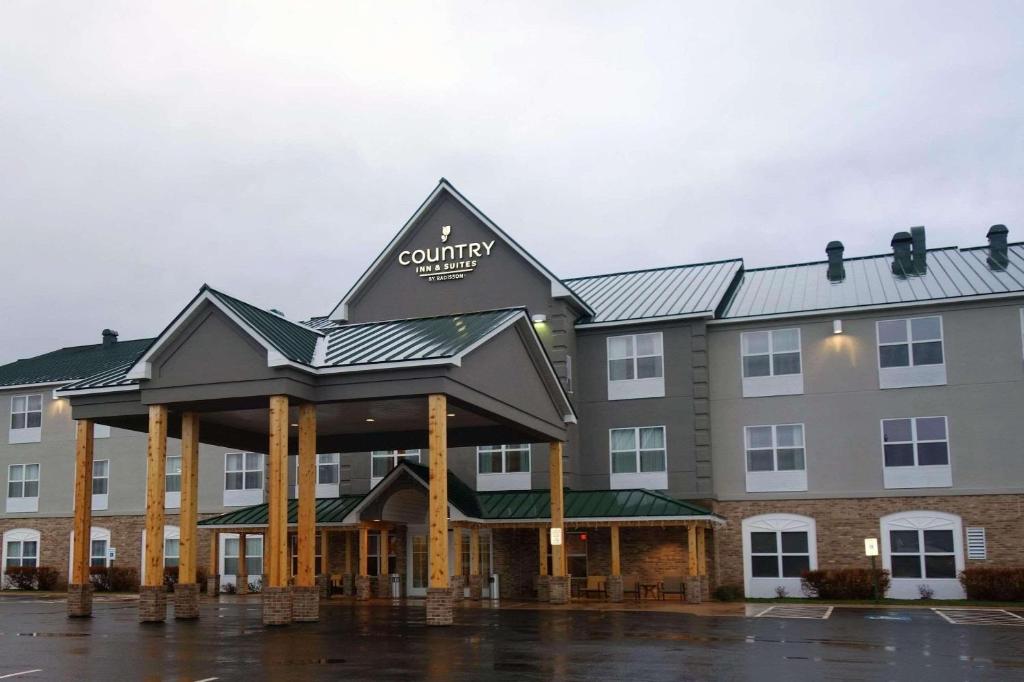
<box><xmin>882</xmin><ymin>417</ymin><xmax>953</xmax><ymax>488</ymax></box>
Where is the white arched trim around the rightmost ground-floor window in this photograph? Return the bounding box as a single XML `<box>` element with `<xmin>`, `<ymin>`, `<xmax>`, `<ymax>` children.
<box><xmin>880</xmin><ymin>510</ymin><xmax>966</xmax><ymax>599</ymax></box>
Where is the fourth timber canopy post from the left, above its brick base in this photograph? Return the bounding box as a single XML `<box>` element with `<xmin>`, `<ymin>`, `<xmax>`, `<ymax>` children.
<box><xmin>263</xmin><ymin>395</ymin><xmax>290</xmax><ymax>588</ymax></box>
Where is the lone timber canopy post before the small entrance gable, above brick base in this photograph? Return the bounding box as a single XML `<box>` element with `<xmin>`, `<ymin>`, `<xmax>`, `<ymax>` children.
<box><xmin>427</xmin><ymin>393</ymin><xmax>449</xmax><ymax>590</ymax></box>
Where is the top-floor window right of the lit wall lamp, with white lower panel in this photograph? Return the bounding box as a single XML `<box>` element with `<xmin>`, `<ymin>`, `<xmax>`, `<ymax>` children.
<box><xmin>876</xmin><ymin>315</ymin><xmax>946</xmax><ymax>388</ymax></box>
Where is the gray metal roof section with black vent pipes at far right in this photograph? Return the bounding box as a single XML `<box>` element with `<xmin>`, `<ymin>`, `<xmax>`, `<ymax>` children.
<box><xmin>722</xmin><ymin>244</ymin><xmax>1024</xmax><ymax>319</ymax></box>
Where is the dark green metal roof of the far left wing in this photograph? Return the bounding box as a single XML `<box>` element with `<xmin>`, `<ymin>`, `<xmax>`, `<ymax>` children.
<box><xmin>0</xmin><ymin>339</ymin><xmax>153</xmax><ymax>386</ymax></box>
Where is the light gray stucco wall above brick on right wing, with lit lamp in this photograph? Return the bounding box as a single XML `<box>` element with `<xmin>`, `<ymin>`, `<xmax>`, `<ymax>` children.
<box><xmin>709</xmin><ymin>301</ymin><xmax>1024</xmax><ymax>500</ymax></box>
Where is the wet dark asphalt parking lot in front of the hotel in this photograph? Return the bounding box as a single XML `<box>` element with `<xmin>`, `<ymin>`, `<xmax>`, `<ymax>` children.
<box><xmin>0</xmin><ymin>597</ymin><xmax>1024</xmax><ymax>682</ymax></box>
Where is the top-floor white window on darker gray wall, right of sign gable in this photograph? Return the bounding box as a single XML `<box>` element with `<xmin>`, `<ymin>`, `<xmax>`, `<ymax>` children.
<box><xmin>607</xmin><ymin>332</ymin><xmax>665</xmax><ymax>400</ymax></box>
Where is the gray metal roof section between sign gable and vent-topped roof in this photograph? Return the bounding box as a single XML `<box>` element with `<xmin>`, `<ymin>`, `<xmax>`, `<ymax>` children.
<box><xmin>564</xmin><ymin>258</ymin><xmax>742</xmax><ymax>326</ymax></box>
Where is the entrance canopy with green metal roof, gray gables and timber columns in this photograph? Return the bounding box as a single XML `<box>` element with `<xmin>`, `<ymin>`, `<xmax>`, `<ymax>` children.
<box><xmin>58</xmin><ymin>286</ymin><xmax>575</xmax><ymax>624</ymax></box>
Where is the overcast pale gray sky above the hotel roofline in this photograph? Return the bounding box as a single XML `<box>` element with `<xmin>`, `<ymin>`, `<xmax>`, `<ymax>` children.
<box><xmin>0</xmin><ymin>0</ymin><xmax>1024</xmax><ymax>361</ymax></box>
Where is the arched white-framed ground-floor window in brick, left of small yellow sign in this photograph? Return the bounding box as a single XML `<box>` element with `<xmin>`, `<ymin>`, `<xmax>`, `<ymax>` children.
<box><xmin>741</xmin><ymin>514</ymin><xmax>818</xmax><ymax>597</ymax></box>
